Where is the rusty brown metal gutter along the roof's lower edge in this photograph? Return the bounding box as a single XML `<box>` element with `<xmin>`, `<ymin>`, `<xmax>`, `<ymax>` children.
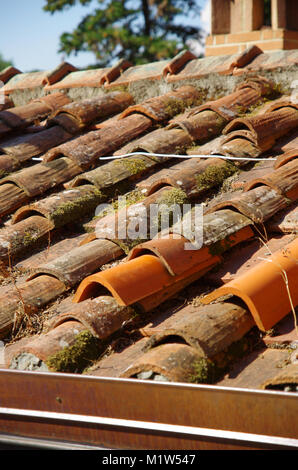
<box><xmin>0</xmin><ymin>369</ymin><xmax>298</xmax><ymax>450</ymax></box>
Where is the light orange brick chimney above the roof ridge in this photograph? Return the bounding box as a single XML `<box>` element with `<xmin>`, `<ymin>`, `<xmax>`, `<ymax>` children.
<box><xmin>205</xmin><ymin>0</ymin><xmax>298</xmax><ymax>56</ymax></box>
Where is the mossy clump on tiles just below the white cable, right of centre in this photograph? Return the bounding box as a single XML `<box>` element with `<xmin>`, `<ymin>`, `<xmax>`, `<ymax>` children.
<box><xmin>196</xmin><ymin>162</ymin><xmax>238</xmax><ymax>191</ymax></box>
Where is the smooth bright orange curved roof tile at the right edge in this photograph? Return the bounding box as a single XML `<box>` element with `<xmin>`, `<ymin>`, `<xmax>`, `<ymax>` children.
<box><xmin>202</xmin><ymin>238</ymin><xmax>298</xmax><ymax>331</ymax></box>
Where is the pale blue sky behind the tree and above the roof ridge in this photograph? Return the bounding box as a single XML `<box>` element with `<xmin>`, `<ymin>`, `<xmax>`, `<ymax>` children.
<box><xmin>0</xmin><ymin>0</ymin><xmax>210</xmax><ymax>72</ymax></box>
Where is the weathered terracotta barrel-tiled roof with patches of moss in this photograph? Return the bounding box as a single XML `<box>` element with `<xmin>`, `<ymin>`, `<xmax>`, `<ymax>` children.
<box><xmin>0</xmin><ymin>47</ymin><xmax>298</xmax><ymax>390</ymax></box>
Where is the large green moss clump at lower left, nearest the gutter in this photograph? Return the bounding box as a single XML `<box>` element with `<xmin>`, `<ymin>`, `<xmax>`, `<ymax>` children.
<box><xmin>46</xmin><ymin>330</ymin><xmax>102</xmax><ymax>373</ymax></box>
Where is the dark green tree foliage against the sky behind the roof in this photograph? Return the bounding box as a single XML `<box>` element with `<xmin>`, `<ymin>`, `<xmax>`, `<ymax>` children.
<box><xmin>44</xmin><ymin>0</ymin><xmax>200</xmax><ymax>66</ymax></box>
